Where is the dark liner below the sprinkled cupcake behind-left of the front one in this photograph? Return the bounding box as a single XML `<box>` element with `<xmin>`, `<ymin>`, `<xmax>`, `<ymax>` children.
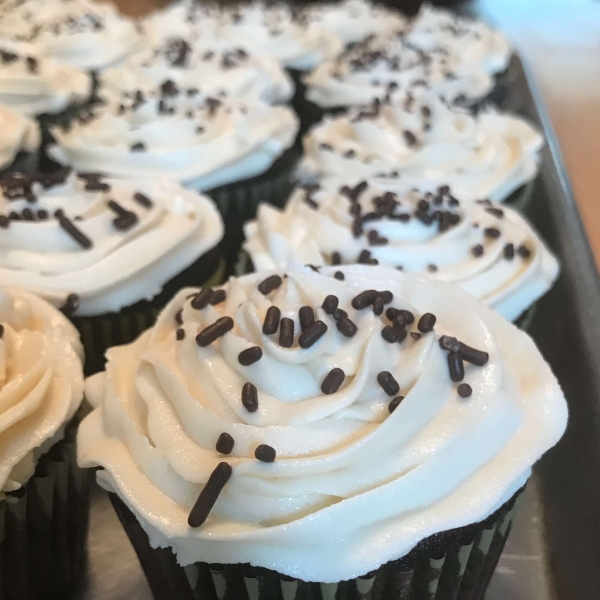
<box><xmin>69</xmin><ymin>247</ymin><xmax>225</xmax><ymax>376</ymax></box>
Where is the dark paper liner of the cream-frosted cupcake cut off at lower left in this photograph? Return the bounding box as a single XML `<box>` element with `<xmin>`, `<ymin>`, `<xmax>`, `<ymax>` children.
<box><xmin>0</xmin><ymin>418</ymin><xmax>91</xmax><ymax>600</ymax></box>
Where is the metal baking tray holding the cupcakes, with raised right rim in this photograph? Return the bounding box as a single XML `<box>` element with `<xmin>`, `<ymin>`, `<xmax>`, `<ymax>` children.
<box><xmin>74</xmin><ymin>58</ymin><xmax>600</xmax><ymax>600</ymax></box>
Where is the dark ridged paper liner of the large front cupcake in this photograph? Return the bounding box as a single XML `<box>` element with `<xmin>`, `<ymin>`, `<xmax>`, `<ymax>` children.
<box><xmin>109</xmin><ymin>489</ymin><xmax>523</xmax><ymax>600</ymax></box>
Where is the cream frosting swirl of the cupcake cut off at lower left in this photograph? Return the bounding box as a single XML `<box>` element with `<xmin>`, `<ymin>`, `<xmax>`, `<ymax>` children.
<box><xmin>0</xmin><ymin>287</ymin><xmax>83</xmax><ymax>497</ymax></box>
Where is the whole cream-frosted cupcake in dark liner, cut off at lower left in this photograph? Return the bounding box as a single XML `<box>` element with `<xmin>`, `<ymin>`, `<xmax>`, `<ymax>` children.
<box><xmin>0</xmin><ymin>287</ymin><xmax>89</xmax><ymax>600</ymax></box>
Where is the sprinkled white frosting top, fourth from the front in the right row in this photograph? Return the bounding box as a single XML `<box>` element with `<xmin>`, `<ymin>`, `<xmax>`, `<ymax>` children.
<box><xmin>304</xmin><ymin>31</ymin><xmax>494</xmax><ymax>108</ymax></box>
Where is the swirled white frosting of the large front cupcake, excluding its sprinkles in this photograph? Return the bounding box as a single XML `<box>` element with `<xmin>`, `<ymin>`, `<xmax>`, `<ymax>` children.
<box><xmin>78</xmin><ymin>266</ymin><xmax>567</xmax><ymax>582</ymax></box>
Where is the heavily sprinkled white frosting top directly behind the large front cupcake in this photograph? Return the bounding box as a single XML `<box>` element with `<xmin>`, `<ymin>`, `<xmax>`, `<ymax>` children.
<box><xmin>244</xmin><ymin>181</ymin><xmax>559</xmax><ymax>320</ymax></box>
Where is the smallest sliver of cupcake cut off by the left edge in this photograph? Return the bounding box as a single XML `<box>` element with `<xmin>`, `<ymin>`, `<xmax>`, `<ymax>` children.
<box><xmin>0</xmin><ymin>104</ymin><xmax>40</xmax><ymax>175</ymax></box>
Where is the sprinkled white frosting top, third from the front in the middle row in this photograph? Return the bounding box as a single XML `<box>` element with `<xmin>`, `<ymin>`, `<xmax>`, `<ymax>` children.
<box><xmin>100</xmin><ymin>36</ymin><xmax>294</xmax><ymax>104</ymax></box>
